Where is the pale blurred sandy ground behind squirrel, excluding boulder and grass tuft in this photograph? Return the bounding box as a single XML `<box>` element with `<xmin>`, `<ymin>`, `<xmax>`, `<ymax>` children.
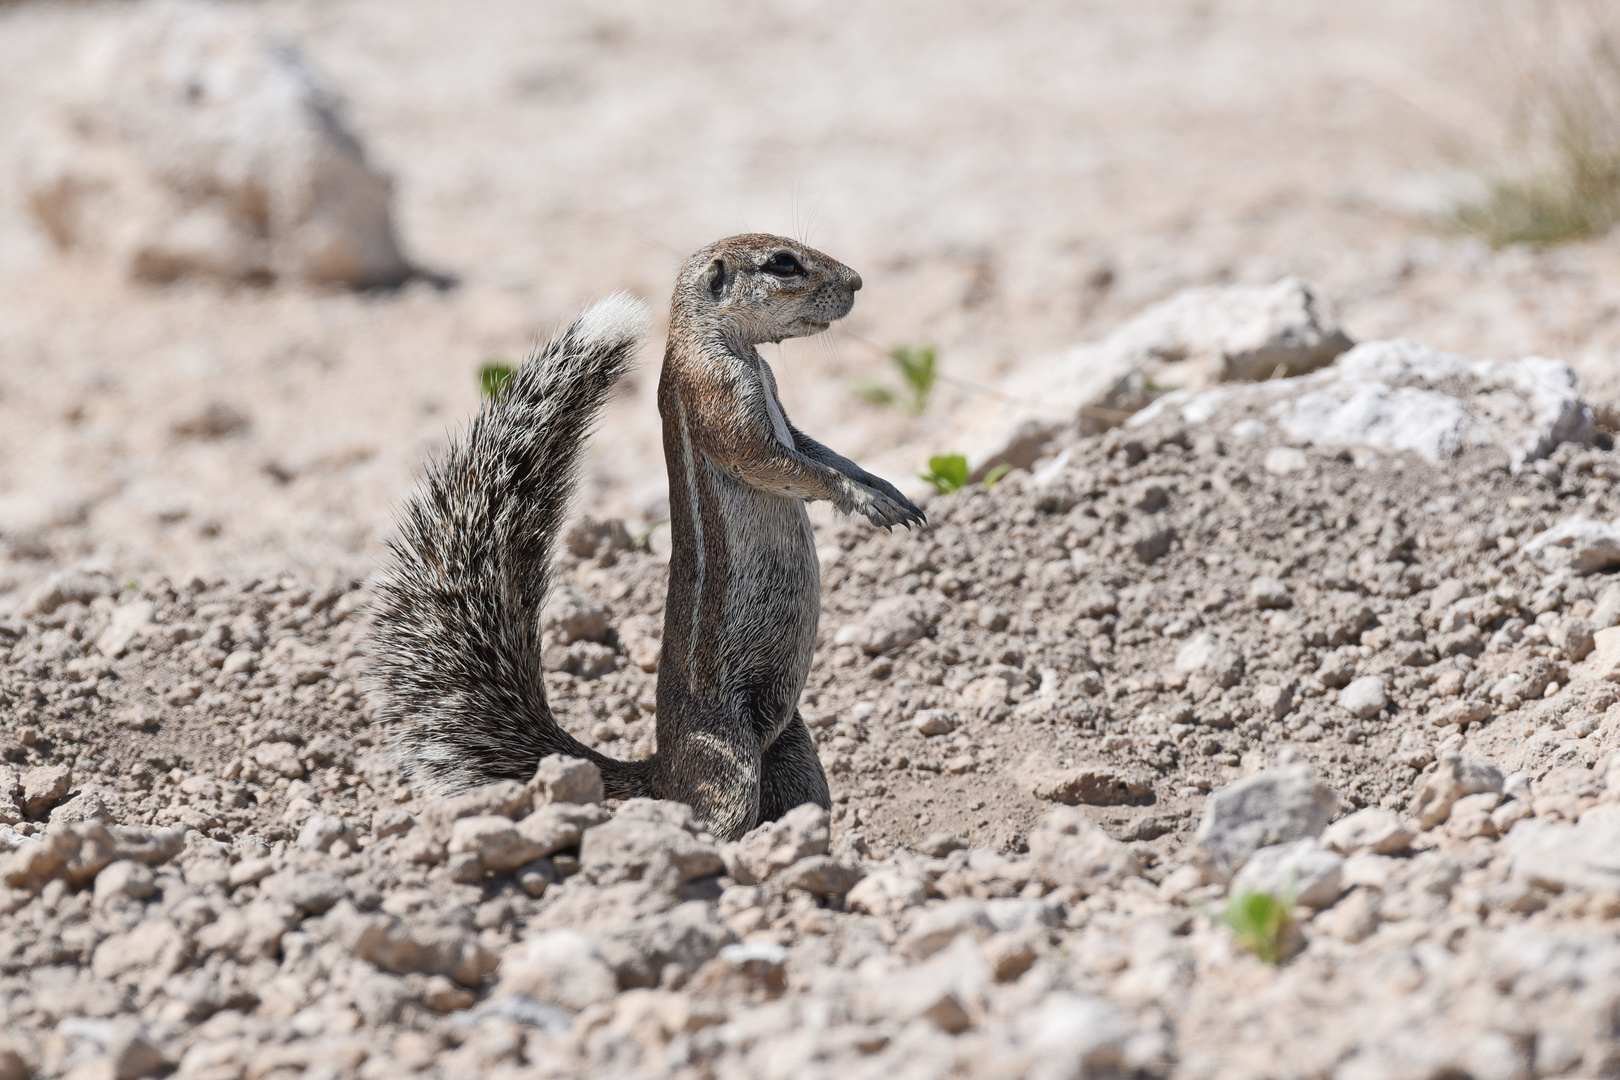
<box><xmin>0</xmin><ymin>3</ymin><xmax>1617</xmax><ymax>609</ymax></box>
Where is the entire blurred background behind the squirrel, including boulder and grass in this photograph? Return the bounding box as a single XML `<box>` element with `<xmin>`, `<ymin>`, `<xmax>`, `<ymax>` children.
<box><xmin>0</xmin><ymin>0</ymin><xmax>1620</xmax><ymax>615</ymax></box>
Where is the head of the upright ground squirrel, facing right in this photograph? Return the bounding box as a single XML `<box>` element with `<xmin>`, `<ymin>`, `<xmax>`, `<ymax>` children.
<box><xmin>674</xmin><ymin>233</ymin><xmax>860</xmax><ymax>345</ymax></box>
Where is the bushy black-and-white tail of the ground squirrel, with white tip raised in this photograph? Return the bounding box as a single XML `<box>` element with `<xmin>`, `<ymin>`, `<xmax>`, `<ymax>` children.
<box><xmin>373</xmin><ymin>293</ymin><xmax>650</xmax><ymax>797</ymax></box>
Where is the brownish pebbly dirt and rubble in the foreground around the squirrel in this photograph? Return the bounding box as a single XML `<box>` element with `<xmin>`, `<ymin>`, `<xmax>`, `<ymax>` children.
<box><xmin>0</xmin><ymin>401</ymin><xmax>1620</xmax><ymax>1077</ymax></box>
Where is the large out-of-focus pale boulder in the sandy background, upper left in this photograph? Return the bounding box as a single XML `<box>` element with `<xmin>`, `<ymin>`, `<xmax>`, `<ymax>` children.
<box><xmin>23</xmin><ymin>0</ymin><xmax>410</xmax><ymax>285</ymax></box>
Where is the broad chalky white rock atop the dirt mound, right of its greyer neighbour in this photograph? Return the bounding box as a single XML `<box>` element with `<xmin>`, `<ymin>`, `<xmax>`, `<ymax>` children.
<box><xmin>1131</xmin><ymin>340</ymin><xmax>1596</xmax><ymax>468</ymax></box>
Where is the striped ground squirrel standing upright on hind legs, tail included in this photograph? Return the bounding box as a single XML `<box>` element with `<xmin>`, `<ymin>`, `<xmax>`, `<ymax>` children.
<box><xmin>373</xmin><ymin>235</ymin><xmax>923</xmax><ymax>839</ymax></box>
